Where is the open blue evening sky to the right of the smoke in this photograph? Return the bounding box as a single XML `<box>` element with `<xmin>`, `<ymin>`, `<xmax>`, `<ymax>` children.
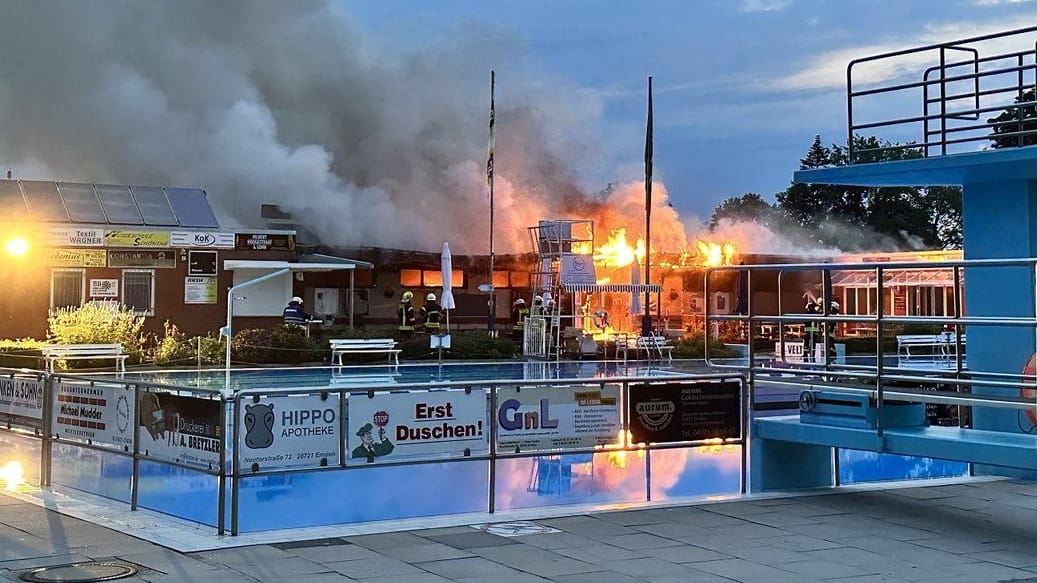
<box><xmin>345</xmin><ymin>0</ymin><xmax>1037</xmax><ymax>219</ymax></box>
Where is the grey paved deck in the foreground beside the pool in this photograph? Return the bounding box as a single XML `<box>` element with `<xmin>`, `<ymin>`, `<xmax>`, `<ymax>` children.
<box><xmin>0</xmin><ymin>480</ymin><xmax>1037</xmax><ymax>583</ymax></box>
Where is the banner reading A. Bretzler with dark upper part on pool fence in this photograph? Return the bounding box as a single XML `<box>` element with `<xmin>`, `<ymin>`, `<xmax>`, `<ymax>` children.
<box><xmin>137</xmin><ymin>391</ymin><xmax>223</xmax><ymax>471</ymax></box>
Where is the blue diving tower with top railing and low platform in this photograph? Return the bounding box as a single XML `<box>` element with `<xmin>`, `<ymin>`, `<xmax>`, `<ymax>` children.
<box><xmin>751</xmin><ymin>27</ymin><xmax>1037</xmax><ymax>491</ymax></box>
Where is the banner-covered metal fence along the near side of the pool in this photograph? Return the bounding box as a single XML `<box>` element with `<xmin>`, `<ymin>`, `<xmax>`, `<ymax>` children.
<box><xmin>0</xmin><ymin>369</ymin><xmax>749</xmax><ymax>535</ymax></box>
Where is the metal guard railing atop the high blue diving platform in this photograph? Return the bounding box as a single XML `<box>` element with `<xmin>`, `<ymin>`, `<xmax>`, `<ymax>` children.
<box><xmin>846</xmin><ymin>27</ymin><xmax>1037</xmax><ymax>164</ymax></box>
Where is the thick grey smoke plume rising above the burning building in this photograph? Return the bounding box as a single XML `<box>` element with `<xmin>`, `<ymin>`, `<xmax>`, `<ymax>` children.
<box><xmin>0</xmin><ymin>0</ymin><xmax>665</xmax><ymax>253</ymax></box>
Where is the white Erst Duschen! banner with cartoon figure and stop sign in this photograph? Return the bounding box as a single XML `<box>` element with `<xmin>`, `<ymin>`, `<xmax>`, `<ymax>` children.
<box><xmin>346</xmin><ymin>390</ymin><xmax>481</xmax><ymax>464</ymax></box>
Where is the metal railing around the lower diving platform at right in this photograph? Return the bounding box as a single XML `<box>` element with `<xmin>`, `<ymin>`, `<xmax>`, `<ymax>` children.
<box><xmin>703</xmin><ymin>258</ymin><xmax>1037</xmax><ymax>435</ymax></box>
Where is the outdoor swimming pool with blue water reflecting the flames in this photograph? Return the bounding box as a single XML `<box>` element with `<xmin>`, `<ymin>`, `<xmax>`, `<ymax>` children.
<box><xmin>0</xmin><ymin>361</ymin><xmax>968</xmax><ymax>532</ymax></box>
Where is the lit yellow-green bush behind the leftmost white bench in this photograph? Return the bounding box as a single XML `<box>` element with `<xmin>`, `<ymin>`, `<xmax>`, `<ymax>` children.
<box><xmin>47</xmin><ymin>302</ymin><xmax>144</xmax><ymax>366</ymax></box>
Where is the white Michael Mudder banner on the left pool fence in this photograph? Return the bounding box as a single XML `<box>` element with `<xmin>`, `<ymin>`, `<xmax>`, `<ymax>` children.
<box><xmin>51</xmin><ymin>383</ymin><xmax>136</xmax><ymax>451</ymax></box>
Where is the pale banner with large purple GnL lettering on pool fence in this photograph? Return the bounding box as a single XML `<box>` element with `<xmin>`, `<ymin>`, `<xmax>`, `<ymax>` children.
<box><xmin>497</xmin><ymin>385</ymin><xmax>620</xmax><ymax>452</ymax></box>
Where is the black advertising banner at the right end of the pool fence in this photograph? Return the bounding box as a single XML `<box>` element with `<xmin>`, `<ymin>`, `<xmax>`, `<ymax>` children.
<box><xmin>629</xmin><ymin>381</ymin><xmax>741</xmax><ymax>443</ymax></box>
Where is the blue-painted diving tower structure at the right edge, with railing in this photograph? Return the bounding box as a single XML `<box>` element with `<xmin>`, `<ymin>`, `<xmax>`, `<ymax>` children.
<box><xmin>751</xmin><ymin>27</ymin><xmax>1037</xmax><ymax>490</ymax></box>
